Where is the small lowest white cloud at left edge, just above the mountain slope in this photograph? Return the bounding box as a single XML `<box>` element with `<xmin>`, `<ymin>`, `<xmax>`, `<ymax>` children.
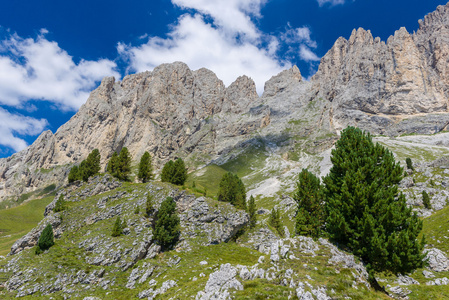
<box><xmin>0</xmin><ymin>108</ymin><xmax>48</xmax><ymax>151</ymax></box>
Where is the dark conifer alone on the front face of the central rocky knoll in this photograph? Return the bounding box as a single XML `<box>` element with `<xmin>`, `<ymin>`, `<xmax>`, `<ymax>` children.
<box><xmin>154</xmin><ymin>197</ymin><xmax>181</xmax><ymax>250</ymax></box>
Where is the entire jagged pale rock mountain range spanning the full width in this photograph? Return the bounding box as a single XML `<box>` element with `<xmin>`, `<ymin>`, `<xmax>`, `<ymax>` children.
<box><xmin>0</xmin><ymin>3</ymin><xmax>449</xmax><ymax>201</ymax></box>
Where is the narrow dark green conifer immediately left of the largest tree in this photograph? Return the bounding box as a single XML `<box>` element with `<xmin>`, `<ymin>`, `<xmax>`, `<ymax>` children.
<box><xmin>293</xmin><ymin>169</ymin><xmax>325</xmax><ymax>237</ymax></box>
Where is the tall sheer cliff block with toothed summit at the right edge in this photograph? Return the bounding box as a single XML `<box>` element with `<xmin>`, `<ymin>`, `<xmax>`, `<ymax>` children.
<box><xmin>312</xmin><ymin>4</ymin><xmax>449</xmax><ymax>131</ymax></box>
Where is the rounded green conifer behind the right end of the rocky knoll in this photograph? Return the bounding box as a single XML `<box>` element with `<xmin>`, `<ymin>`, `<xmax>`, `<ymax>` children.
<box><xmin>218</xmin><ymin>172</ymin><xmax>246</xmax><ymax>209</ymax></box>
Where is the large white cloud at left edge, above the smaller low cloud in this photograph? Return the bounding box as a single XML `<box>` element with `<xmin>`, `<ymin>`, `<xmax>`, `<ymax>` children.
<box><xmin>0</xmin><ymin>29</ymin><xmax>120</xmax><ymax>110</ymax></box>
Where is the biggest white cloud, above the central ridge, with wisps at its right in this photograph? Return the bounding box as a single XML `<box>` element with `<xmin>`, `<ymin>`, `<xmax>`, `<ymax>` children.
<box><xmin>117</xmin><ymin>0</ymin><xmax>316</xmax><ymax>94</ymax></box>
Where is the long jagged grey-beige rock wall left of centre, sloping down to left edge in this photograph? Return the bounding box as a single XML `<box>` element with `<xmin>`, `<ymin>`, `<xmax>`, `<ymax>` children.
<box><xmin>0</xmin><ymin>62</ymin><xmax>269</xmax><ymax>198</ymax></box>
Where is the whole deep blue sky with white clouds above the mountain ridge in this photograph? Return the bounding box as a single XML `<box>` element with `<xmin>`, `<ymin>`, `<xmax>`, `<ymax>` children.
<box><xmin>0</xmin><ymin>0</ymin><xmax>447</xmax><ymax>157</ymax></box>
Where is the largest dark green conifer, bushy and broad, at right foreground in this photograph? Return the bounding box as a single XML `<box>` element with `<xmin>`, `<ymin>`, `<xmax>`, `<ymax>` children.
<box><xmin>324</xmin><ymin>127</ymin><xmax>424</xmax><ymax>279</ymax></box>
